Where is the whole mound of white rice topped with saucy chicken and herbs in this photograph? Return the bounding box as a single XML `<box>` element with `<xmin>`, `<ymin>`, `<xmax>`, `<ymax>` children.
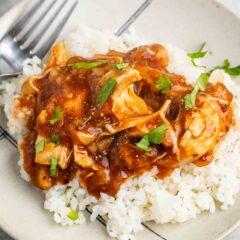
<box><xmin>0</xmin><ymin>25</ymin><xmax>240</xmax><ymax>239</ymax></box>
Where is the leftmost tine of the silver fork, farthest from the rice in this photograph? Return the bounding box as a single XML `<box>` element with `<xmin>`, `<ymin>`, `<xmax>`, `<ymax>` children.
<box><xmin>7</xmin><ymin>0</ymin><xmax>45</xmax><ymax>36</ymax></box>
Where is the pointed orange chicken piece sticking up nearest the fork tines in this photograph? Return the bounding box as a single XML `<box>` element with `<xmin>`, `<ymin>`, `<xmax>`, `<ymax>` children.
<box><xmin>45</xmin><ymin>42</ymin><xmax>70</xmax><ymax>70</ymax></box>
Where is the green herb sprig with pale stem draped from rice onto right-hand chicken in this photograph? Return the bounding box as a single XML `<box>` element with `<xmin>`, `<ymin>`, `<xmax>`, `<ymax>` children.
<box><xmin>183</xmin><ymin>73</ymin><xmax>209</xmax><ymax>110</ymax></box>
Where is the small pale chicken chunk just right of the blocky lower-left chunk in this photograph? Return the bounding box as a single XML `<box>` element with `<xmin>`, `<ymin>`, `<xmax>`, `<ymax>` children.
<box><xmin>73</xmin><ymin>145</ymin><xmax>97</xmax><ymax>170</ymax></box>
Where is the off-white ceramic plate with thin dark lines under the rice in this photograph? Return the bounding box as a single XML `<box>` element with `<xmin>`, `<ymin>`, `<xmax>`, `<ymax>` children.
<box><xmin>0</xmin><ymin>0</ymin><xmax>240</xmax><ymax>240</ymax></box>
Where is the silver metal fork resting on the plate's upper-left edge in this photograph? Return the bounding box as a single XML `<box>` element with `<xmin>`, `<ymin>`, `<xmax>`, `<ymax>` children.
<box><xmin>0</xmin><ymin>0</ymin><xmax>78</xmax><ymax>78</ymax></box>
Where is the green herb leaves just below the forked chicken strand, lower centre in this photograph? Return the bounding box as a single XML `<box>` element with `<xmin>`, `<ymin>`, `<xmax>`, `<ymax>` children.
<box><xmin>136</xmin><ymin>124</ymin><xmax>168</xmax><ymax>152</ymax></box>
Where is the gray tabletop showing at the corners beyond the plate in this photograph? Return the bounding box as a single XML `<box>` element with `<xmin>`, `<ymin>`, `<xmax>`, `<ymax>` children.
<box><xmin>0</xmin><ymin>0</ymin><xmax>240</xmax><ymax>240</ymax></box>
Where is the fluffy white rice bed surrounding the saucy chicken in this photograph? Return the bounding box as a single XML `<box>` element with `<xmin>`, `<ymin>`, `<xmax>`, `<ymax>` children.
<box><xmin>0</xmin><ymin>26</ymin><xmax>240</xmax><ymax>240</ymax></box>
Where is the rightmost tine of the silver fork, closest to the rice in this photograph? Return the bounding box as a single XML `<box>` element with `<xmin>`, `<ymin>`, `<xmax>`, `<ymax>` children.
<box><xmin>34</xmin><ymin>0</ymin><xmax>78</xmax><ymax>58</ymax></box>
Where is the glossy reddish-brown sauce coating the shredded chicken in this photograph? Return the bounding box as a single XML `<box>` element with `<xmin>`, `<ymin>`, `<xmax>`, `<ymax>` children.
<box><xmin>20</xmin><ymin>44</ymin><xmax>232</xmax><ymax>197</ymax></box>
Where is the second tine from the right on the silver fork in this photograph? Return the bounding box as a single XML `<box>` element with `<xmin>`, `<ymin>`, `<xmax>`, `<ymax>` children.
<box><xmin>25</xmin><ymin>0</ymin><xmax>67</xmax><ymax>51</ymax></box>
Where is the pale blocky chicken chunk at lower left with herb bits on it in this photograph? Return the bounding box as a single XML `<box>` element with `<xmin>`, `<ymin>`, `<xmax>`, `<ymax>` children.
<box><xmin>35</xmin><ymin>135</ymin><xmax>71</xmax><ymax>169</ymax></box>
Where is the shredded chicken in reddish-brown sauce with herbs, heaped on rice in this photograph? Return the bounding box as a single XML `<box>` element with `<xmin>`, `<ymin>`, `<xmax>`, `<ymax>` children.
<box><xmin>15</xmin><ymin>43</ymin><xmax>233</xmax><ymax>197</ymax></box>
